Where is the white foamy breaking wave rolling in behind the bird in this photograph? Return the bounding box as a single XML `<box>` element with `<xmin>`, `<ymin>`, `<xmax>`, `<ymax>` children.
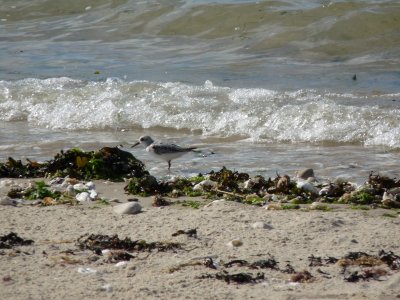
<box><xmin>0</xmin><ymin>78</ymin><xmax>400</xmax><ymax>148</ymax></box>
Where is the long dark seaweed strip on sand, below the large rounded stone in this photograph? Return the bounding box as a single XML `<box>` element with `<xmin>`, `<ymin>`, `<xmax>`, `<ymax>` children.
<box><xmin>77</xmin><ymin>234</ymin><xmax>182</xmax><ymax>252</ymax></box>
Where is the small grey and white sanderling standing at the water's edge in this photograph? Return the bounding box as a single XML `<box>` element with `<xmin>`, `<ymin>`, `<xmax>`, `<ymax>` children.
<box><xmin>131</xmin><ymin>135</ymin><xmax>196</xmax><ymax>170</ymax></box>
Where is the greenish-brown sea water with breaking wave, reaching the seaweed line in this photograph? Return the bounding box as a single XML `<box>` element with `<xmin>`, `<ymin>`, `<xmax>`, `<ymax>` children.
<box><xmin>0</xmin><ymin>0</ymin><xmax>400</xmax><ymax>182</ymax></box>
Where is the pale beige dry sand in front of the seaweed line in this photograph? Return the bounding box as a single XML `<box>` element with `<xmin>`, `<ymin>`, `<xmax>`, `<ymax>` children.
<box><xmin>0</xmin><ymin>182</ymin><xmax>400</xmax><ymax>299</ymax></box>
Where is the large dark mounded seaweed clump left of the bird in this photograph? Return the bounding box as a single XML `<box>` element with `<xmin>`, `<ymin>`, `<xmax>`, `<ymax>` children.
<box><xmin>0</xmin><ymin>147</ymin><xmax>148</xmax><ymax>181</ymax></box>
